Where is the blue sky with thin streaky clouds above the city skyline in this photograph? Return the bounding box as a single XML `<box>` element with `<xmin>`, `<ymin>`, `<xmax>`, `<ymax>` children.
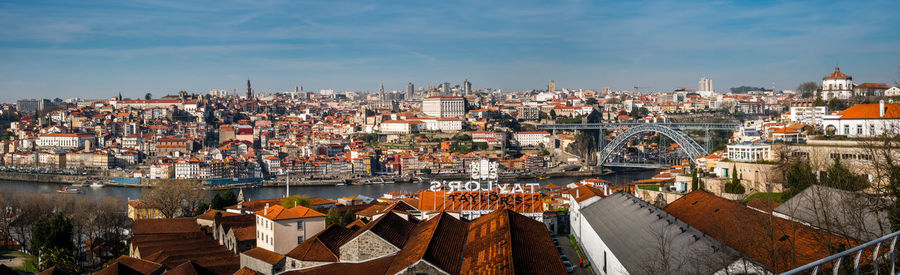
<box><xmin>0</xmin><ymin>0</ymin><xmax>900</xmax><ymax>102</ymax></box>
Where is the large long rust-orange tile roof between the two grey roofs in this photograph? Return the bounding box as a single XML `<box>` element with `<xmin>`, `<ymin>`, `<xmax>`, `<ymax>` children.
<box><xmin>665</xmin><ymin>190</ymin><xmax>859</xmax><ymax>273</ymax></box>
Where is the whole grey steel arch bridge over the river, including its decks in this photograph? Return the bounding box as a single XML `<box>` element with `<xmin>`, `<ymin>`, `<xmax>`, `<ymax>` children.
<box><xmin>538</xmin><ymin>123</ymin><xmax>741</xmax><ymax>168</ymax></box>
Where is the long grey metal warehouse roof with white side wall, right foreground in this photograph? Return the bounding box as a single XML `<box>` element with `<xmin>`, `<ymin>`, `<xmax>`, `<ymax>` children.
<box><xmin>581</xmin><ymin>192</ymin><xmax>740</xmax><ymax>274</ymax></box>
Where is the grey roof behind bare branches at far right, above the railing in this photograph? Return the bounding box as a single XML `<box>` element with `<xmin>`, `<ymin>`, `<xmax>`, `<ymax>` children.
<box><xmin>775</xmin><ymin>185</ymin><xmax>891</xmax><ymax>241</ymax></box>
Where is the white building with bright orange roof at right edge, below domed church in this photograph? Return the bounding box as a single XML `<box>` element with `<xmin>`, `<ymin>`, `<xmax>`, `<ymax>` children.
<box><xmin>822</xmin><ymin>100</ymin><xmax>900</xmax><ymax>137</ymax></box>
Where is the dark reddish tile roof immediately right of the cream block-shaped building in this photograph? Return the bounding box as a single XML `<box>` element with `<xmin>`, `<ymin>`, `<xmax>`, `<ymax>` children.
<box><xmin>285</xmin><ymin>224</ymin><xmax>354</xmax><ymax>262</ymax></box>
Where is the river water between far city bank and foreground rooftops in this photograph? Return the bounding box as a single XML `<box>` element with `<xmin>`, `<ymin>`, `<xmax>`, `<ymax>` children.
<box><xmin>0</xmin><ymin>170</ymin><xmax>656</xmax><ymax>200</ymax></box>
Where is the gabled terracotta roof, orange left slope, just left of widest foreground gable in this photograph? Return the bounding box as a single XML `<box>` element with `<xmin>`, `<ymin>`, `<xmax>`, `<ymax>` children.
<box><xmin>387</xmin><ymin>212</ymin><xmax>468</xmax><ymax>274</ymax></box>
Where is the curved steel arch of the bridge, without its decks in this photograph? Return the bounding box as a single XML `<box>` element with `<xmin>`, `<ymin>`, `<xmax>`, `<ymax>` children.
<box><xmin>598</xmin><ymin>123</ymin><xmax>707</xmax><ymax>165</ymax></box>
